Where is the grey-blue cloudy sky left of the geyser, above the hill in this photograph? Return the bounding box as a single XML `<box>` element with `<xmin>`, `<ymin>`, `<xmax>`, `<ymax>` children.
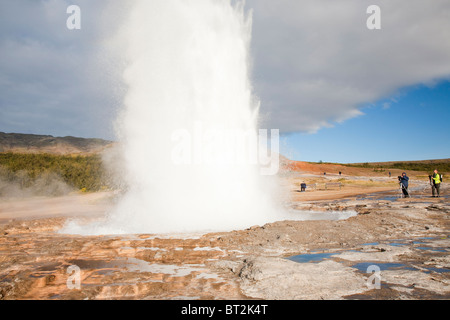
<box><xmin>0</xmin><ymin>0</ymin><xmax>125</xmax><ymax>138</ymax></box>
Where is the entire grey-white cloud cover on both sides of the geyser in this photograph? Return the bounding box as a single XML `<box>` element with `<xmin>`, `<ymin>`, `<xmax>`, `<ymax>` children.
<box><xmin>0</xmin><ymin>0</ymin><xmax>450</xmax><ymax>138</ymax></box>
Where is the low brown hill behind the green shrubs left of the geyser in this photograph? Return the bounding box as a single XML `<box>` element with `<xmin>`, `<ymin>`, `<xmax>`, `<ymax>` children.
<box><xmin>0</xmin><ymin>132</ymin><xmax>114</xmax><ymax>155</ymax></box>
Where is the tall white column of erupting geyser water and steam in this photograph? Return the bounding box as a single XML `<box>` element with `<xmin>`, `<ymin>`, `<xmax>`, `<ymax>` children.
<box><xmin>62</xmin><ymin>0</ymin><xmax>284</xmax><ymax>234</ymax></box>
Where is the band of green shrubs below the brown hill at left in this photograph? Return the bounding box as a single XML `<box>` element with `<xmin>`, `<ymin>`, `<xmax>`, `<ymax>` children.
<box><xmin>0</xmin><ymin>153</ymin><xmax>108</xmax><ymax>191</ymax></box>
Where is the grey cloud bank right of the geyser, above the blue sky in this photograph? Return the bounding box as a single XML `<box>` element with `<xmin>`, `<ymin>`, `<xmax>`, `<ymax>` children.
<box><xmin>247</xmin><ymin>0</ymin><xmax>450</xmax><ymax>132</ymax></box>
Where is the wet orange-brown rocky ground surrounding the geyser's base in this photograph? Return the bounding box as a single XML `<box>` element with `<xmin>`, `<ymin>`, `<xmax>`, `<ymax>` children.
<box><xmin>0</xmin><ymin>177</ymin><xmax>450</xmax><ymax>300</ymax></box>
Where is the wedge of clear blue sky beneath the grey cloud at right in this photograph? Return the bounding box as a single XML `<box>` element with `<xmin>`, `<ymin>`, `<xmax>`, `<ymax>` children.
<box><xmin>281</xmin><ymin>81</ymin><xmax>450</xmax><ymax>163</ymax></box>
